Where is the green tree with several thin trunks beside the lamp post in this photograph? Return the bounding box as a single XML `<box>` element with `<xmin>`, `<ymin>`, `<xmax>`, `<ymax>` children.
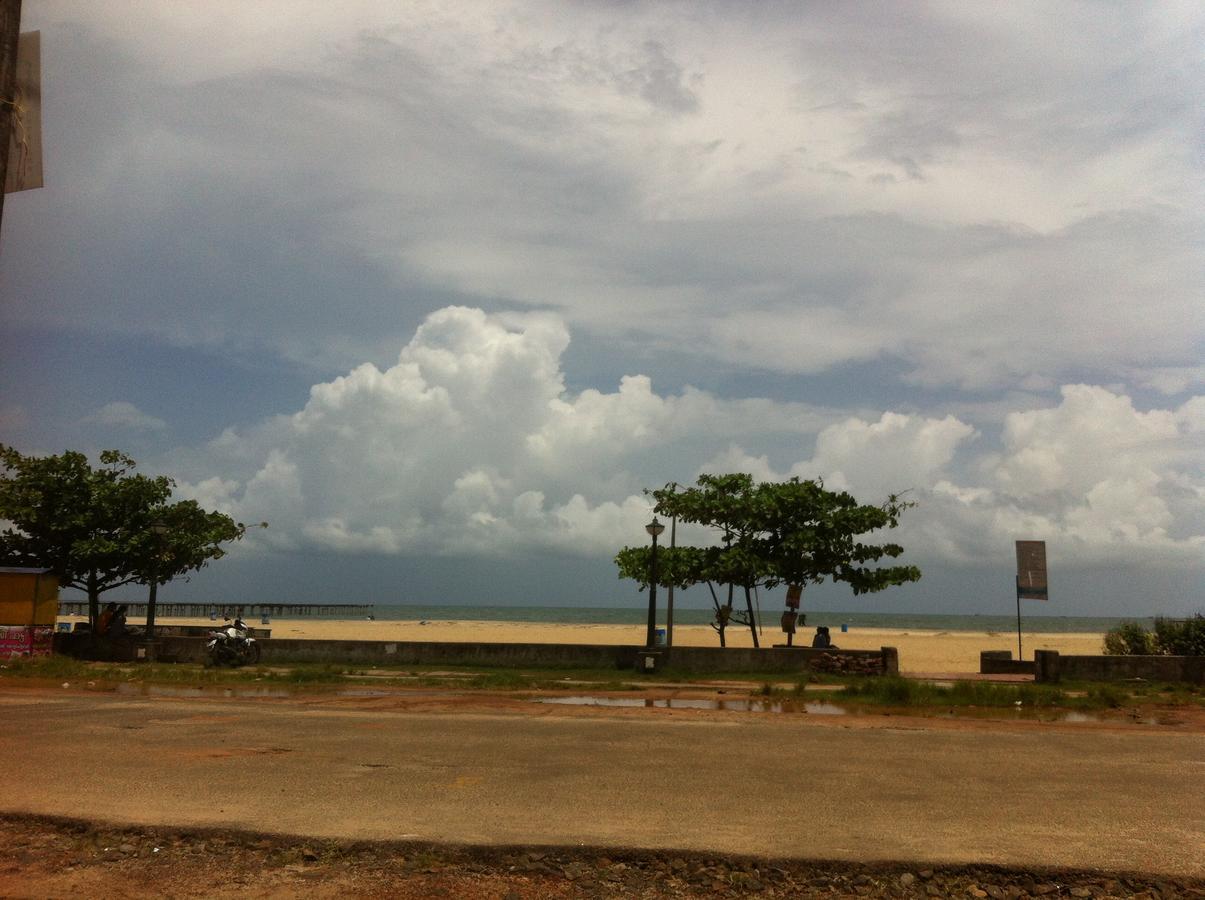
<box><xmin>616</xmin><ymin>472</ymin><xmax>921</xmax><ymax>646</ymax></box>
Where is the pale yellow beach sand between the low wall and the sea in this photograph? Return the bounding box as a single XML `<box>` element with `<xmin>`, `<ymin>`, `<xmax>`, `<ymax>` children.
<box><xmin>145</xmin><ymin>618</ymin><xmax>1104</xmax><ymax>673</ymax></box>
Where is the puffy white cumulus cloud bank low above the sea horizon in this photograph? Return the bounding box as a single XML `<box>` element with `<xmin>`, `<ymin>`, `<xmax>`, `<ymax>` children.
<box><xmin>172</xmin><ymin>307</ymin><xmax>1205</xmax><ymax>564</ymax></box>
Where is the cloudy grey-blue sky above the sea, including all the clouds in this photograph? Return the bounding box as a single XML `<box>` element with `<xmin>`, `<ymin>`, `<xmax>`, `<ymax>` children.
<box><xmin>0</xmin><ymin>0</ymin><xmax>1205</xmax><ymax>616</ymax></box>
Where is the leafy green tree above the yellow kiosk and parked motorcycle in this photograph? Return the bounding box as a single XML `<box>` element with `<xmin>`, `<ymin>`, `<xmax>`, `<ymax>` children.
<box><xmin>0</xmin><ymin>443</ymin><xmax>254</xmax><ymax>625</ymax></box>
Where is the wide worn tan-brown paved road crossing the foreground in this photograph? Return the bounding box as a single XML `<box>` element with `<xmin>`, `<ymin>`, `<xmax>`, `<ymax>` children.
<box><xmin>0</xmin><ymin>689</ymin><xmax>1205</xmax><ymax>877</ymax></box>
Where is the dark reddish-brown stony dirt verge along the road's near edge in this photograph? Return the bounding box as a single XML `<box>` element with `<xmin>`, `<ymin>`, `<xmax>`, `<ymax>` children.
<box><xmin>0</xmin><ymin>816</ymin><xmax>1205</xmax><ymax>900</ymax></box>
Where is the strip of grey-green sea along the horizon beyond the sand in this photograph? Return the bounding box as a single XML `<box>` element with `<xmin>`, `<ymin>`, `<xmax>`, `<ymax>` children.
<box><xmin>342</xmin><ymin>604</ymin><xmax>1154</xmax><ymax>634</ymax></box>
